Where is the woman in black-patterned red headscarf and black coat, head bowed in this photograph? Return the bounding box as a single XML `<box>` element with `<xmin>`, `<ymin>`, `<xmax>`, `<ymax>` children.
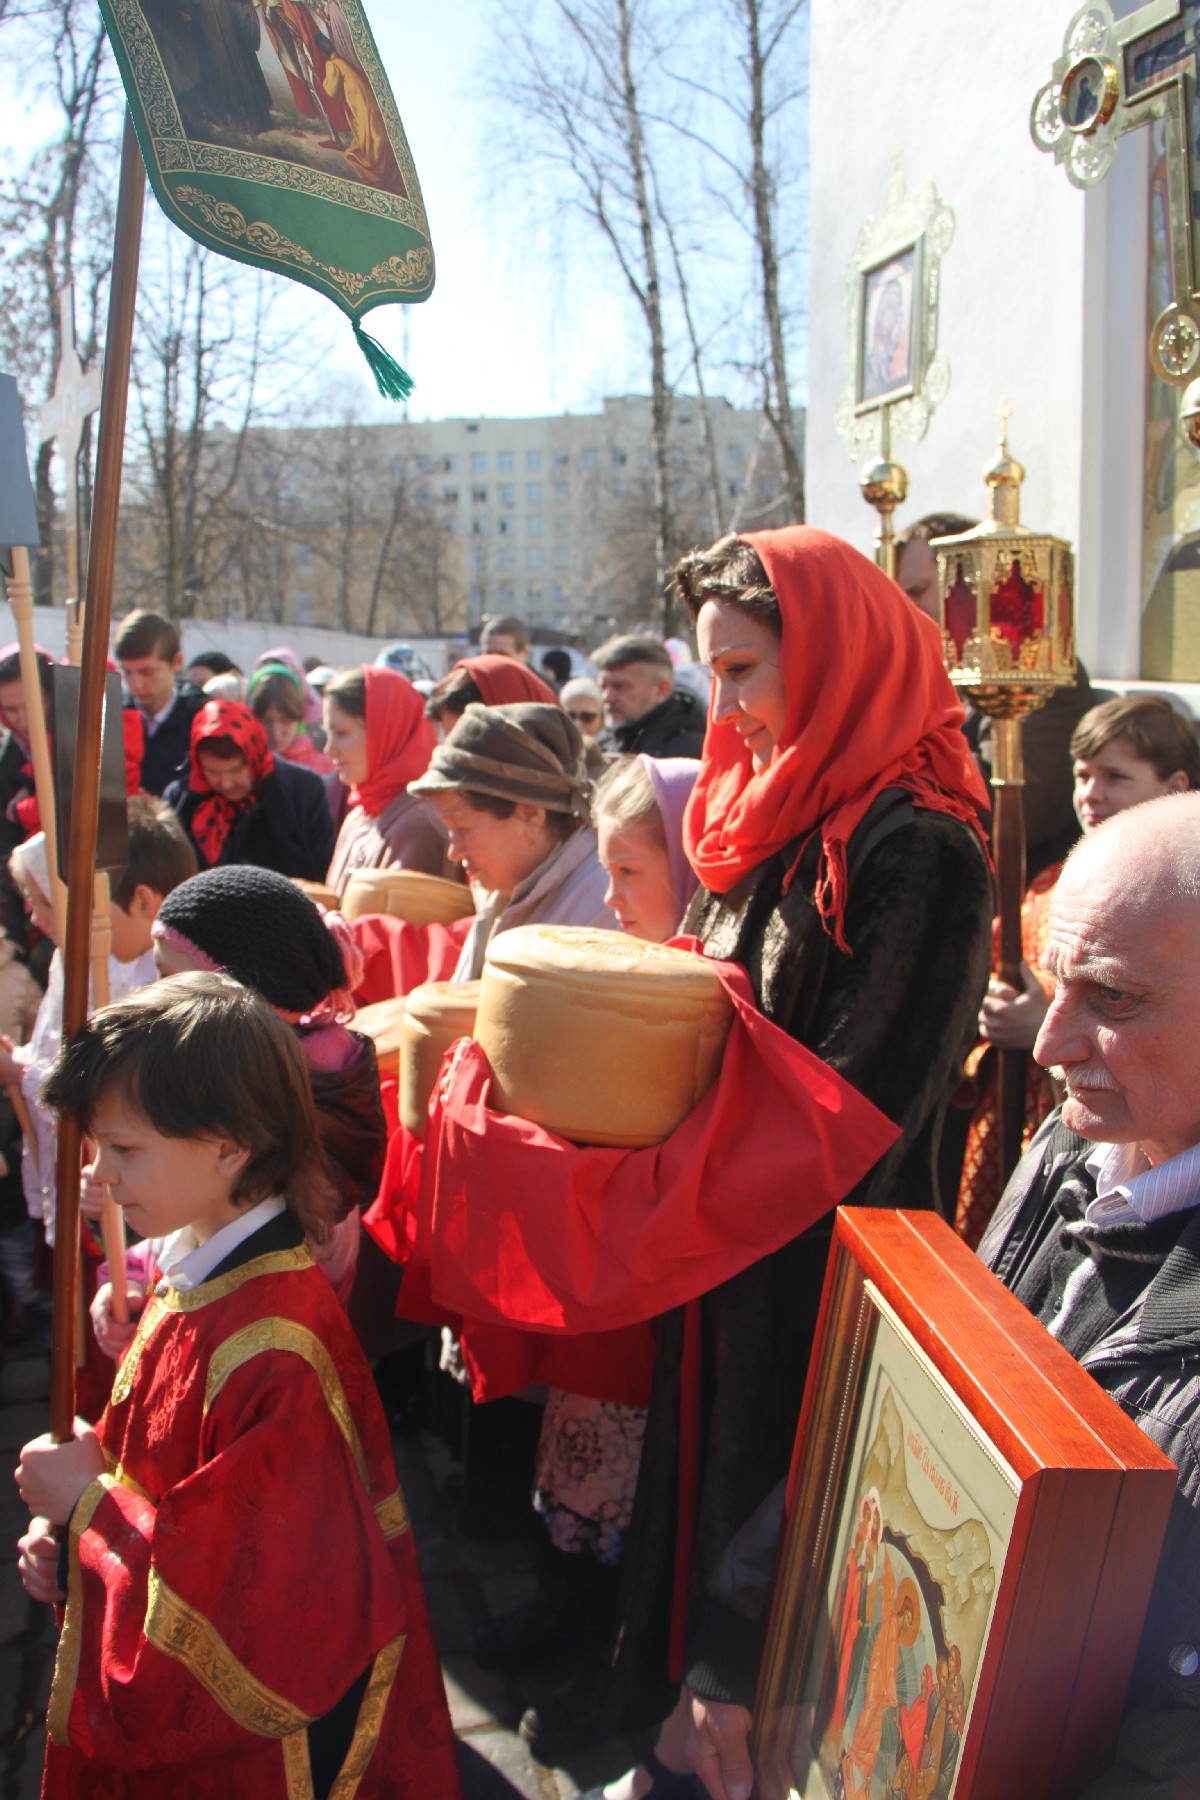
<box><xmin>164</xmin><ymin>700</ymin><xmax>333</xmax><ymax>880</ymax></box>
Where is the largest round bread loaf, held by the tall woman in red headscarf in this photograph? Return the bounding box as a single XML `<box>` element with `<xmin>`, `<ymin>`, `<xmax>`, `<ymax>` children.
<box><xmin>475</xmin><ymin>925</ymin><xmax>732</xmax><ymax>1148</ymax></box>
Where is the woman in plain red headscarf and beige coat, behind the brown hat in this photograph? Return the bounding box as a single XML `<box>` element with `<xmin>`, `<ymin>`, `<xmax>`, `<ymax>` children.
<box><xmin>322</xmin><ymin>668</ymin><xmax>446</xmax><ymax>895</ymax></box>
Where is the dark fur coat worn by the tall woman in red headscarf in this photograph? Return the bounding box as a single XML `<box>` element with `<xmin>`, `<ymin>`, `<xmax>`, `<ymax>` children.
<box><xmin>604</xmin><ymin>792</ymin><xmax>991</xmax><ymax>1724</ymax></box>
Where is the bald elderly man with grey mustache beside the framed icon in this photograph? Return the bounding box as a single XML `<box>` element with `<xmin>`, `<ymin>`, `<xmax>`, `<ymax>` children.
<box><xmin>979</xmin><ymin>794</ymin><xmax>1200</xmax><ymax>1800</ymax></box>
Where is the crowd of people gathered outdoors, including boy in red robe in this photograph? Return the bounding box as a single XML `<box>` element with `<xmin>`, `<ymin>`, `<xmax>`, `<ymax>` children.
<box><xmin>0</xmin><ymin>518</ymin><xmax>1200</xmax><ymax>1800</ymax></box>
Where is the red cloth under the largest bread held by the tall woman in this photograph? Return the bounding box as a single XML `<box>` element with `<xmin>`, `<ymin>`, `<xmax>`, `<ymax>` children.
<box><xmin>367</xmin><ymin>940</ymin><xmax>900</xmax><ymax>1399</ymax></box>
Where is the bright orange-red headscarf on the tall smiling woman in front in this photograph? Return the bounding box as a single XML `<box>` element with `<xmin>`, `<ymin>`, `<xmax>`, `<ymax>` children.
<box><xmin>684</xmin><ymin>526</ymin><xmax>988</xmax><ymax>949</ymax></box>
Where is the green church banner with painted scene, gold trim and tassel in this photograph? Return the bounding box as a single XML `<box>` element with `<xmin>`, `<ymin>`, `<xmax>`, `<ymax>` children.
<box><xmin>99</xmin><ymin>0</ymin><xmax>434</xmax><ymax>398</ymax></box>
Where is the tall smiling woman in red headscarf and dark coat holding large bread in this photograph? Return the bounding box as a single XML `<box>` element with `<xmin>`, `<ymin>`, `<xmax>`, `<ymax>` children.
<box><xmin>590</xmin><ymin>526</ymin><xmax>991</xmax><ymax>1800</ymax></box>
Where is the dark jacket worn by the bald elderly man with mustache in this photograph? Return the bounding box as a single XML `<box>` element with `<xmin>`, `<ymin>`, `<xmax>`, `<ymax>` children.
<box><xmin>979</xmin><ymin>1112</ymin><xmax>1200</xmax><ymax>1800</ymax></box>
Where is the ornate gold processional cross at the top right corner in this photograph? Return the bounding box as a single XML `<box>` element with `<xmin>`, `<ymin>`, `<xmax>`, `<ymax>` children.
<box><xmin>1029</xmin><ymin>0</ymin><xmax>1200</xmax><ymax>385</ymax></box>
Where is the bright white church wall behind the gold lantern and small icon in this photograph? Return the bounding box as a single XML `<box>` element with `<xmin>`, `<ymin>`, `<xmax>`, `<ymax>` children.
<box><xmin>808</xmin><ymin>0</ymin><xmax>1146</xmax><ymax>677</ymax></box>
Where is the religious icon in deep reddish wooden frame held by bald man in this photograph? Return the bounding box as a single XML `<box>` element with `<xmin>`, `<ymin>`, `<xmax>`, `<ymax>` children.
<box><xmin>754</xmin><ymin>1208</ymin><xmax>1175</xmax><ymax>1800</ymax></box>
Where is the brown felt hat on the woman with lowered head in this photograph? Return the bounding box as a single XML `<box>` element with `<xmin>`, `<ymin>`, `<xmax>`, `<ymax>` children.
<box><xmin>408</xmin><ymin>704</ymin><xmax>590</xmax><ymax>819</ymax></box>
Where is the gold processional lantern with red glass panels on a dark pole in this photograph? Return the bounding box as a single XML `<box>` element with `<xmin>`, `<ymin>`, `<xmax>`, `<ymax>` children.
<box><xmin>930</xmin><ymin>412</ymin><xmax>1076</xmax><ymax>1177</ymax></box>
